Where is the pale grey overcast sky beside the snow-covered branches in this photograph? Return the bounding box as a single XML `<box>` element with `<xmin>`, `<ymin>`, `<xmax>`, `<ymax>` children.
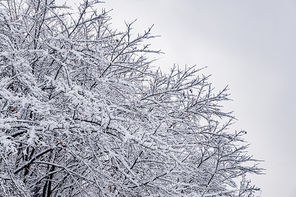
<box><xmin>69</xmin><ymin>0</ymin><xmax>296</xmax><ymax>197</ymax></box>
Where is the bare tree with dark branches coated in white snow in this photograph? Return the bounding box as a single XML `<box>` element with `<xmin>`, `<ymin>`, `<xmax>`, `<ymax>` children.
<box><xmin>0</xmin><ymin>0</ymin><xmax>262</xmax><ymax>197</ymax></box>
